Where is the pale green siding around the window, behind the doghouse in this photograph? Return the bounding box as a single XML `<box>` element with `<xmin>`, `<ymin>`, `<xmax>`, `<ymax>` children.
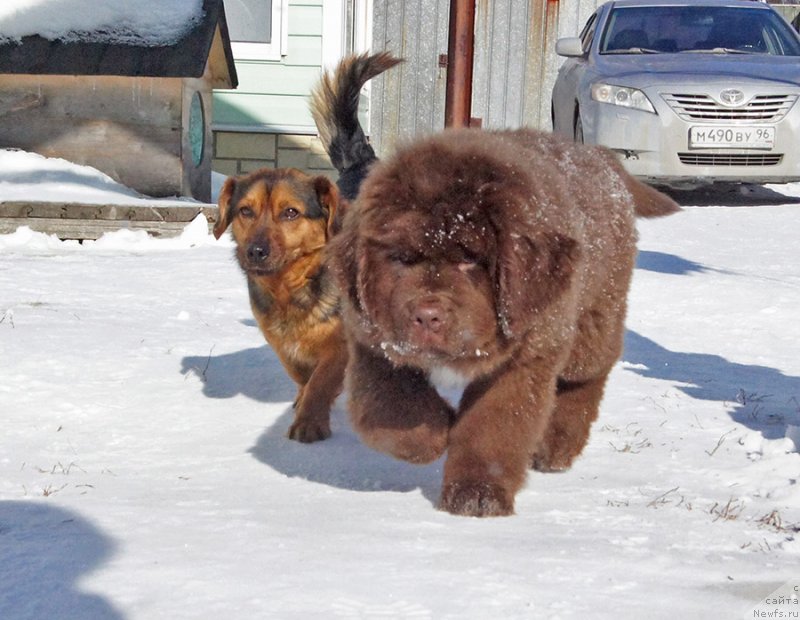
<box><xmin>213</xmin><ymin>0</ymin><xmax>322</xmax><ymax>133</ymax></box>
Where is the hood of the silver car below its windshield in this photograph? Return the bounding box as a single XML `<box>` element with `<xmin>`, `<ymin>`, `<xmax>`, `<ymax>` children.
<box><xmin>592</xmin><ymin>52</ymin><xmax>800</xmax><ymax>88</ymax></box>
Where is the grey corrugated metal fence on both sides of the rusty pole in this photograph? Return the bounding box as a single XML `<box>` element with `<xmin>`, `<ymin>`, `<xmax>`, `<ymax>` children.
<box><xmin>371</xmin><ymin>0</ymin><xmax>602</xmax><ymax>154</ymax></box>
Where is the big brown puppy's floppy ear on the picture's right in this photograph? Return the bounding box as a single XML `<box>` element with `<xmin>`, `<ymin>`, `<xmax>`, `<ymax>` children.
<box><xmin>495</xmin><ymin>231</ymin><xmax>580</xmax><ymax>338</ymax></box>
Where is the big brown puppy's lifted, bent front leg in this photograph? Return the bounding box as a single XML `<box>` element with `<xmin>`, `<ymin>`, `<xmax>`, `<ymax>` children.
<box><xmin>348</xmin><ymin>343</ymin><xmax>453</xmax><ymax>463</ymax></box>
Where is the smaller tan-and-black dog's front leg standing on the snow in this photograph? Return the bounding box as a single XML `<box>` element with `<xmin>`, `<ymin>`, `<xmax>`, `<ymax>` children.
<box><xmin>288</xmin><ymin>329</ymin><xmax>347</xmax><ymax>443</ymax></box>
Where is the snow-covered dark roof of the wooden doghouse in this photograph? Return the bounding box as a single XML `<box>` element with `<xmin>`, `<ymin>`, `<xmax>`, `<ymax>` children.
<box><xmin>0</xmin><ymin>0</ymin><xmax>238</xmax><ymax>88</ymax></box>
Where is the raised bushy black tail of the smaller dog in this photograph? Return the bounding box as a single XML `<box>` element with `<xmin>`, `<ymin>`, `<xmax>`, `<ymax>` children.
<box><xmin>311</xmin><ymin>52</ymin><xmax>402</xmax><ymax>200</ymax></box>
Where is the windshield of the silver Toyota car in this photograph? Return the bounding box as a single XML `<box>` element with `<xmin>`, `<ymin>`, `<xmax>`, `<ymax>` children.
<box><xmin>600</xmin><ymin>5</ymin><xmax>800</xmax><ymax>56</ymax></box>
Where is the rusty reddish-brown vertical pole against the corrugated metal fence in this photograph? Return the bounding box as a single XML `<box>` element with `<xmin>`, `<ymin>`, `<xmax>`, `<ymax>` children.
<box><xmin>444</xmin><ymin>0</ymin><xmax>475</xmax><ymax>127</ymax></box>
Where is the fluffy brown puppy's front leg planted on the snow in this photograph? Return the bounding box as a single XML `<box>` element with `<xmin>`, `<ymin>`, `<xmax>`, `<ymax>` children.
<box><xmin>439</xmin><ymin>363</ymin><xmax>556</xmax><ymax>517</ymax></box>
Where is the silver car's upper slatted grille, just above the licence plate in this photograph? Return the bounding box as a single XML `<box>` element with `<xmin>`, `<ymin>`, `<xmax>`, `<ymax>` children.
<box><xmin>662</xmin><ymin>94</ymin><xmax>797</xmax><ymax>122</ymax></box>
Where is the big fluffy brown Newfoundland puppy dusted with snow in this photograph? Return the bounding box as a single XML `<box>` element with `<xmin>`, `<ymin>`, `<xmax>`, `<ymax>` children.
<box><xmin>328</xmin><ymin>130</ymin><xmax>678</xmax><ymax>516</ymax></box>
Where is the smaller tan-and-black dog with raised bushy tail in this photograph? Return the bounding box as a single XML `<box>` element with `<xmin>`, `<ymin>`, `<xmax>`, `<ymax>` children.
<box><xmin>214</xmin><ymin>53</ymin><xmax>400</xmax><ymax>442</ymax></box>
